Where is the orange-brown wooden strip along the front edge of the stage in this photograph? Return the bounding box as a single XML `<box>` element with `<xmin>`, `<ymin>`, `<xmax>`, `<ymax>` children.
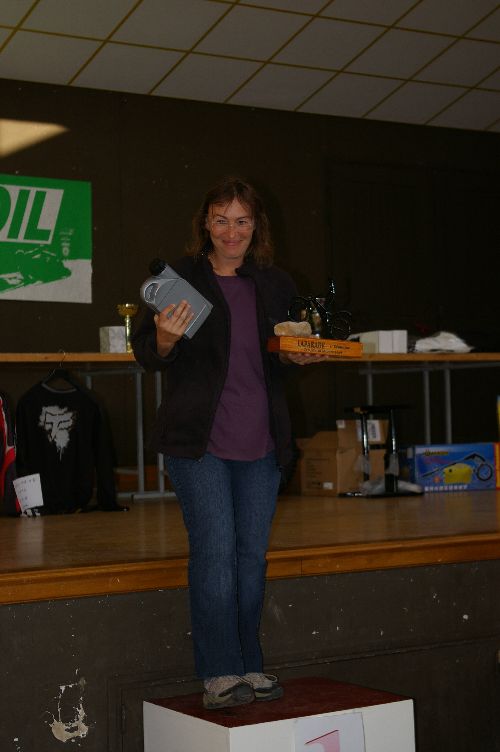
<box><xmin>0</xmin><ymin>535</ymin><xmax>500</xmax><ymax>604</ymax></box>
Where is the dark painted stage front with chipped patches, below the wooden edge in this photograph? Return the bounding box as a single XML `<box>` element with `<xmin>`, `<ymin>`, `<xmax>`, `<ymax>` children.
<box><xmin>0</xmin><ymin>561</ymin><xmax>500</xmax><ymax>752</ymax></box>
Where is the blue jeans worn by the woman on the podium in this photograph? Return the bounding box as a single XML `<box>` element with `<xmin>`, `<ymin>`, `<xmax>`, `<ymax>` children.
<box><xmin>165</xmin><ymin>452</ymin><xmax>280</xmax><ymax>679</ymax></box>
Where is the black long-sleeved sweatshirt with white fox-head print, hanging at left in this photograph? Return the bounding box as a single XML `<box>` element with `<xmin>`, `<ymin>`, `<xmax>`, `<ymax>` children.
<box><xmin>16</xmin><ymin>380</ymin><xmax>117</xmax><ymax>513</ymax></box>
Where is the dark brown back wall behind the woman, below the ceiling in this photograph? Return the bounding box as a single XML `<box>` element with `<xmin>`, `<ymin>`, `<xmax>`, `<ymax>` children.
<box><xmin>0</xmin><ymin>80</ymin><xmax>500</xmax><ymax>464</ymax></box>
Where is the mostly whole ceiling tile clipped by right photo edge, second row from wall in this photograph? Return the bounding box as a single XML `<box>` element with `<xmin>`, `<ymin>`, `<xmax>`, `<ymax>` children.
<box><xmin>416</xmin><ymin>39</ymin><xmax>500</xmax><ymax>86</ymax></box>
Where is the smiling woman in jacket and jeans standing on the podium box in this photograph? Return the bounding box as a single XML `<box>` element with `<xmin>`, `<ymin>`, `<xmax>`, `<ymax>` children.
<box><xmin>133</xmin><ymin>178</ymin><xmax>324</xmax><ymax>709</ymax></box>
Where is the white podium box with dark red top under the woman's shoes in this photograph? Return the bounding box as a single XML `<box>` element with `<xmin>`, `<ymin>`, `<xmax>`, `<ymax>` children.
<box><xmin>144</xmin><ymin>678</ymin><xmax>415</xmax><ymax>752</ymax></box>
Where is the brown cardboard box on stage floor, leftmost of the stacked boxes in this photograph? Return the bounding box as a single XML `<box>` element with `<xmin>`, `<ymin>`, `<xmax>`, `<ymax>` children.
<box><xmin>301</xmin><ymin>431</ymin><xmax>337</xmax><ymax>496</ymax></box>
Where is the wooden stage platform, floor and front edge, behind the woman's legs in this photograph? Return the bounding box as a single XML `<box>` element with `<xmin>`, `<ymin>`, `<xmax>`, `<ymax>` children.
<box><xmin>0</xmin><ymin>491</ymin><xmax>500</xmax><ymax>604</ymax></box>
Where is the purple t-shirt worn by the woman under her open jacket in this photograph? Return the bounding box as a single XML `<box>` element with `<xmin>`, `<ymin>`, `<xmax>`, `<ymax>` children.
<box><xmin>207</xmin><ymin>276</ymin><xmax>274</xmax><ymax>460</ymax></box>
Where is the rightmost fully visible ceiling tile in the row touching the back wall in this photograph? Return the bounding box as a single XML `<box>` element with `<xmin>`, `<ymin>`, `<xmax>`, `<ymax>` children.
<box><xmin>367</xmin><ymin>81</ymin><xmax>465</xmax><ymax>124</ymax></box>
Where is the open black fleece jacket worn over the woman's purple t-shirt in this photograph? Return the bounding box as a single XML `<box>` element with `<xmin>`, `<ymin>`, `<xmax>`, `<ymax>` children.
<box><xmin>132</xmin><ymin>255</ymin><xmax>297</xmax><ymax>467</ymax></box>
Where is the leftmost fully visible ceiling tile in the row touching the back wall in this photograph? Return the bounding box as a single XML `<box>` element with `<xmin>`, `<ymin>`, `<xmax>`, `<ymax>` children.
<box><xmin>74</xmin><ymin>43</ymin><xmax>183</xmax><ymax>94</ymax></box>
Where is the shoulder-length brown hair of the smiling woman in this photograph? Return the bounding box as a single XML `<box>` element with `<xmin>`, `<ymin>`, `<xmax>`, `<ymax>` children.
<box><xmin>186</xmin><ymin>177</ymin><xmax>274</xmax><ymax>267</ymax></box>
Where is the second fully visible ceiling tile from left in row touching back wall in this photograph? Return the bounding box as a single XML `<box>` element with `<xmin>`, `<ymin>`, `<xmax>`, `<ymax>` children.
<box><xmin>154</xmin><ymin>54</ymin><xmax>260</xmax><ymax>102</ymax></box>
